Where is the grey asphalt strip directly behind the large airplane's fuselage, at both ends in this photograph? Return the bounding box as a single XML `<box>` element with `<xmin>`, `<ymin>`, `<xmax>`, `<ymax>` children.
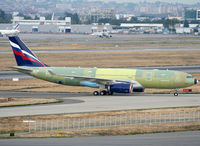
<box><xmin>0</xmin><ymin>66</ymin><xmax>200</xmax><ymax>80</ymax></box>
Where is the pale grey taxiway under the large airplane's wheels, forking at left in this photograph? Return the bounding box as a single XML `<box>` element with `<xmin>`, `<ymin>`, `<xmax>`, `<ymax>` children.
<box><xmin>0</xmin><ymin>92</ymin><xmax>200</xmax><ymax>117</ymax></box>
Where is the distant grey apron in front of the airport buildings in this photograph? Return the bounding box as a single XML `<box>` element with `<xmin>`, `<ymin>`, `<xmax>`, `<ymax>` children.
<box><xmin>0</xmin><ymin>33</ymin><xmax>200</xmax><ymax>46</ymax></box>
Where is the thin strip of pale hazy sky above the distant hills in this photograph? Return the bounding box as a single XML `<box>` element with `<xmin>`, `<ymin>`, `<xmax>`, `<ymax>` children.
<box><xmin>96</xmin><ymin>0</ymin><xmax>200</xmax><ymax>4</ymax></box>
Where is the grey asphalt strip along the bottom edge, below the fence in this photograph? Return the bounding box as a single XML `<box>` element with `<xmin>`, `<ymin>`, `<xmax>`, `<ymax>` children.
<box><xmin>0</xmin><ymin>131</ymin><xmax>200</xmax><ymax>146</ymax></box>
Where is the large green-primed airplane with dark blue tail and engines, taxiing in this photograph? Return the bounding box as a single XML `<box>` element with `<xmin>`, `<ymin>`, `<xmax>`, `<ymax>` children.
<box><xmin>8</xmin><ymin>36</ymin><xmax>198</xmax><ymax>96</ymax></box>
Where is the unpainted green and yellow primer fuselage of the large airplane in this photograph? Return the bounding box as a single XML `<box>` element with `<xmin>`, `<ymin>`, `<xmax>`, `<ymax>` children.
<box><xmin>15</xmin><ymin>66</ymin><xmax>194</xmax><ymax>89</ymax></box>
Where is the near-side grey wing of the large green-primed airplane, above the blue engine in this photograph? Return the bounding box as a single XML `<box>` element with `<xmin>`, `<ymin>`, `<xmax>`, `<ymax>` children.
<box><xmin>48</xmin><ymin>70</ymin><xmax>142</xmax><ymax>86</ymax></box>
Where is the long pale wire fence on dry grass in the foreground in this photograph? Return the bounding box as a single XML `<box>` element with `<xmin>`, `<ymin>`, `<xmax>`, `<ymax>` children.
<box><xmin>29</xmin><ymin>111</ymin><xmax>200</xmax><ymax>132</ymax></box>
